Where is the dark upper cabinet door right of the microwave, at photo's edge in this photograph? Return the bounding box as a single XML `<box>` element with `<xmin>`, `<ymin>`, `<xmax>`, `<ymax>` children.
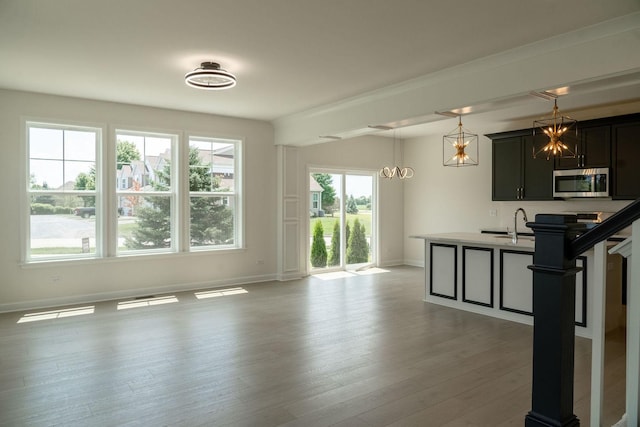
<box><xmin>613</xmin><ymin>123</ymin><xmax>640</xmax><ymax>199</ymax></box>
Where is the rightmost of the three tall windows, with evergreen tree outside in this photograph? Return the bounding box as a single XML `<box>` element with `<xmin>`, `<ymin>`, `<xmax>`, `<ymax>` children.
<box><xmin>189</xmin><ymin>137</ymin><xmax>239</xmax><ymax>248</ymax></box>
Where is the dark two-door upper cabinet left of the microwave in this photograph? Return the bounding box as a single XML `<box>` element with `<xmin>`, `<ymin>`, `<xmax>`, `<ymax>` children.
<box><xmin>487</xmin><ymin>131</ymin><xmax>553</xmax><ymax>201</ymax></box>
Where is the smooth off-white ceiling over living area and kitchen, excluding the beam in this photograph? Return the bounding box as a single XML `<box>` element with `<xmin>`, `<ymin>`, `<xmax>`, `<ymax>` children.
<box><xmin>0</xmin><ymin>0</ymin><xmax>640</xmax><ymax>144</ymax></box>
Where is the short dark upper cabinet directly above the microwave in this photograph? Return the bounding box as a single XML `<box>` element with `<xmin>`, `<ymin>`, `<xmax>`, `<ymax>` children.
<box><xmin>556</xmin><ymin>125</ymin><xmax>611</xmax><ymax>169</ymax></box>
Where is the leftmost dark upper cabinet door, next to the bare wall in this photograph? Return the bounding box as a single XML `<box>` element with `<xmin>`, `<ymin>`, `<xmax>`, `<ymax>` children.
<box><xmin>492</xmin><ymin>136</ymin><xmax>522</xmax><ymax>200</ymax></box>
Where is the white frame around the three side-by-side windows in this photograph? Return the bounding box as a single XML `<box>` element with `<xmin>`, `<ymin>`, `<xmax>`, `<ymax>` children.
<box><xmin>20</xmin><ymin>117</ymin><xmax>245</xmax><ymax>265</ymax></box>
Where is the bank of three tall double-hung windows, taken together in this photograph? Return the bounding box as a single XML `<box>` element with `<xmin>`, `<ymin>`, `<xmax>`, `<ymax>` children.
<box><xmin>24</xmin><ymin>121</ymin><xmax>242</xmax><ymax>262</ymax></box>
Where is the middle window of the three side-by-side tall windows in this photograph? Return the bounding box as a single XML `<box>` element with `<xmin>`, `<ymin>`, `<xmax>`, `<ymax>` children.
<box><xmin>115</xmin><ymin>131</ymin><xmax>177</xmax><ymax>253</ymax></box>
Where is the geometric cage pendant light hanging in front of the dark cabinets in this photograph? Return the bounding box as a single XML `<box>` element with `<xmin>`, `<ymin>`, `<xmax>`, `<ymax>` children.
<box><xmin>533</xmin><ymin>99</ymin><xmax>578</xmax><ymax>160</ymax></box>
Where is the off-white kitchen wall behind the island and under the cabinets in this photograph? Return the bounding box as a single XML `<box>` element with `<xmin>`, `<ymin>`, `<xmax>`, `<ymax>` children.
<box><xmin>404</xmin><ymin>133</ymin><xmax>629</xmax><ymax>266</ymax></box>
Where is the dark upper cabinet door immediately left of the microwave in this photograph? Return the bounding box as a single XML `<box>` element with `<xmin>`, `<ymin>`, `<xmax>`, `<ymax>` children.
<box><xmin>522</xmin><ymin>135</ymin><xmax>553</xmax><ymax>200</ymax></box>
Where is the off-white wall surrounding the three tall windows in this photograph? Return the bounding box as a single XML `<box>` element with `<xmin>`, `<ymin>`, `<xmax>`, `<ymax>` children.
<box><xmin>0</xmin><ymin>90</ymin><xmax>277</xmax><ymax>311</ymax></box>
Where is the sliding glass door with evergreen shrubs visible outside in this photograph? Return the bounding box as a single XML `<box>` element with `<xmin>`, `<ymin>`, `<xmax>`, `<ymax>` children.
<box><xmin>308</xmin><ymin>169</ymin><xmax>376</xmax><ymax>272</ymax></box>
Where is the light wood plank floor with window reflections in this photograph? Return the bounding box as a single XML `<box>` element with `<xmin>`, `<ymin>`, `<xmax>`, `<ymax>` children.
<box><xmin>0</xmin><ymin>267</ymin><xmax>624</xmax><ymax>427</ymax></box>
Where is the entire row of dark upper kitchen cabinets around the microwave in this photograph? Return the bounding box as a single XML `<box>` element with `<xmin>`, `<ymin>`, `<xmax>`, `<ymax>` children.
<box><xmin>487</xmin><ymin>113</ymin><xmax>640</xmax><ymax>201</ymax></box>
